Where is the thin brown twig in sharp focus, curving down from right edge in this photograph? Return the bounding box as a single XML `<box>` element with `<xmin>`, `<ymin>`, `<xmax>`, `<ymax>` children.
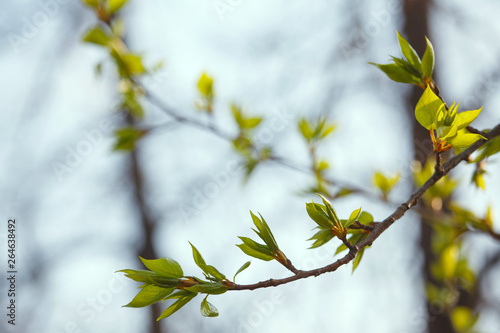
<box><xmin>228</xmin><ymin>124</ymin><xmax>500</xmax><ymax>290</ymax></box>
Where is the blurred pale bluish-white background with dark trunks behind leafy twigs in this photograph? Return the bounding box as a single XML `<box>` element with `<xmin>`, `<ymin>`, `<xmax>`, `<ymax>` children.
<box><xmin>0</xmin><ymin>0</ymin><xmax>500</xmax><ymax>333</ymax></box>
